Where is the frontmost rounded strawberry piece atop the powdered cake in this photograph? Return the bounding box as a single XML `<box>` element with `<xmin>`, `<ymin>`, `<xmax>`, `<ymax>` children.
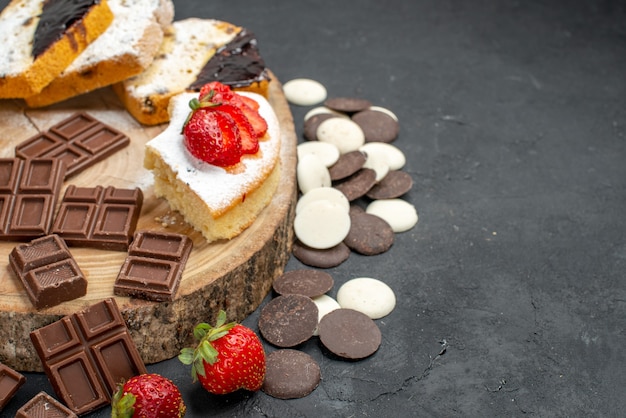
<box><xmin>183</xmin><ymin>107</ymin><xmax>242</xmax><ymax>167</ymax></box>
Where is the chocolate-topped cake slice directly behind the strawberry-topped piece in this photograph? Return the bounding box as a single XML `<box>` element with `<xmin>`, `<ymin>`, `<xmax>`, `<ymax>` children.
<box><xmin>113</xmin><ymin>18</ymin><xmax>269</xmax><ymax>125</ymax></box>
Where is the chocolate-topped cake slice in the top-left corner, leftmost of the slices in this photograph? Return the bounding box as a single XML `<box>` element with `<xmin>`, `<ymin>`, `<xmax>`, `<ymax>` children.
<box><xmin>0</xmin><ymin>0</ymin><xmax>113</xmax><ymax>98</ymax></box>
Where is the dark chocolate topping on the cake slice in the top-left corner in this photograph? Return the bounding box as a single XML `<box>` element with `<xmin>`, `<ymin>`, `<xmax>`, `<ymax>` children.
<box><xmin>32</xmin><ymin>0</ymin><xmax>100</xmax><ymax>58</ymax></box>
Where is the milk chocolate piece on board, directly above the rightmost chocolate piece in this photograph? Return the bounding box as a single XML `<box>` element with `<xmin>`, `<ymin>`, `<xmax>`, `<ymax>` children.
<box><xmin>52</xmin><ymin>185</ymin><xmax>143</xmax><ymax>251</ymax></box>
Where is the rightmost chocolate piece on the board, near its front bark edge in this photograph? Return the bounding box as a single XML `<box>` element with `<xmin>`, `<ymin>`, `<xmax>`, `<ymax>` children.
<box><xmin>113</xmin><ymin>231</ymin><xmax>193</xmax><ymax>302</ymax></box>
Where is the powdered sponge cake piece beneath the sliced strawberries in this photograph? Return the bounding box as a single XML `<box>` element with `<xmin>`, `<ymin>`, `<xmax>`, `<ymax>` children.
<box><xmin>144</xmin><ymin>92</ymin><xmax>280</xmax><ymax>242</ymax></box>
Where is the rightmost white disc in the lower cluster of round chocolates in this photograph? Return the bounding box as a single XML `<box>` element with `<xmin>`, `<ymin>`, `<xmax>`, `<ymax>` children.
<box><xmin>337</xmin><ymin>277</ymin><xmax>396</xmax><ymax>319</ymax></box>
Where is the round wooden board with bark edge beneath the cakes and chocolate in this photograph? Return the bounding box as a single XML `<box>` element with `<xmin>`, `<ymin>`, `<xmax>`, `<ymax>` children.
<box><xmin>0</xmin><ymin>77</ymin><xmax>297</xmax><ymax>371</ymax></box>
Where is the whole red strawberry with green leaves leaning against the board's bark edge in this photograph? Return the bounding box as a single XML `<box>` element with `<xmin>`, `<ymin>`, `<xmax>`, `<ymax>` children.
<box><xmin>178</xmin><ymin>311</ymin><xmax>265</xmax><ymax>395</ymax></box>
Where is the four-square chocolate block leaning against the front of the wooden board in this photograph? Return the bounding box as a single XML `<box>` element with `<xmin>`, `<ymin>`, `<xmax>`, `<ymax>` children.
<box><xmin>30</xmin><ymin>298</ymin><xmax>147</xmax><ymax>415</ymax></box>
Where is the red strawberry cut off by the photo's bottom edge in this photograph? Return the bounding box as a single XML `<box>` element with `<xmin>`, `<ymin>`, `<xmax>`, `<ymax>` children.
<box><xmin>111</xmin><ymin>373</ymin><xmax>186</xmax><ymax>418</ymax></box>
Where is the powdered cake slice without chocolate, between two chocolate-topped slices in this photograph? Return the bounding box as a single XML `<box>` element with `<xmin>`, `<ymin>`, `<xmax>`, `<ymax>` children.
<box><xmin>26</xmin><ymin>0</ymin><xmax>174</xmax><ymax>107</ymax></box>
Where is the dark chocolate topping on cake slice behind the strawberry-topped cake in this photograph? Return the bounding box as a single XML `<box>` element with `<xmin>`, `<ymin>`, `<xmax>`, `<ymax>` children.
<box><xmin>189</xmin><ymin>29</ymin><xmax>268</xmax><ymax>91</ymax></box>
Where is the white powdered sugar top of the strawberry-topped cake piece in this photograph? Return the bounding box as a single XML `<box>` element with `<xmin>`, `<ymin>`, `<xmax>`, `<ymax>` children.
<box><xmin>146</xmin><ymin>92</ymin><xmax>280</xmax><ymax>216</ymax></box>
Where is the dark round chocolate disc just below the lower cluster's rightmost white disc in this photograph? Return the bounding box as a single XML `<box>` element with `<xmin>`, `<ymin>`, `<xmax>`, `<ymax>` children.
<box><xmin>318</xmin><ymin>308</ymin><xmax>382</xmax><ymax>360</ymax></box>
